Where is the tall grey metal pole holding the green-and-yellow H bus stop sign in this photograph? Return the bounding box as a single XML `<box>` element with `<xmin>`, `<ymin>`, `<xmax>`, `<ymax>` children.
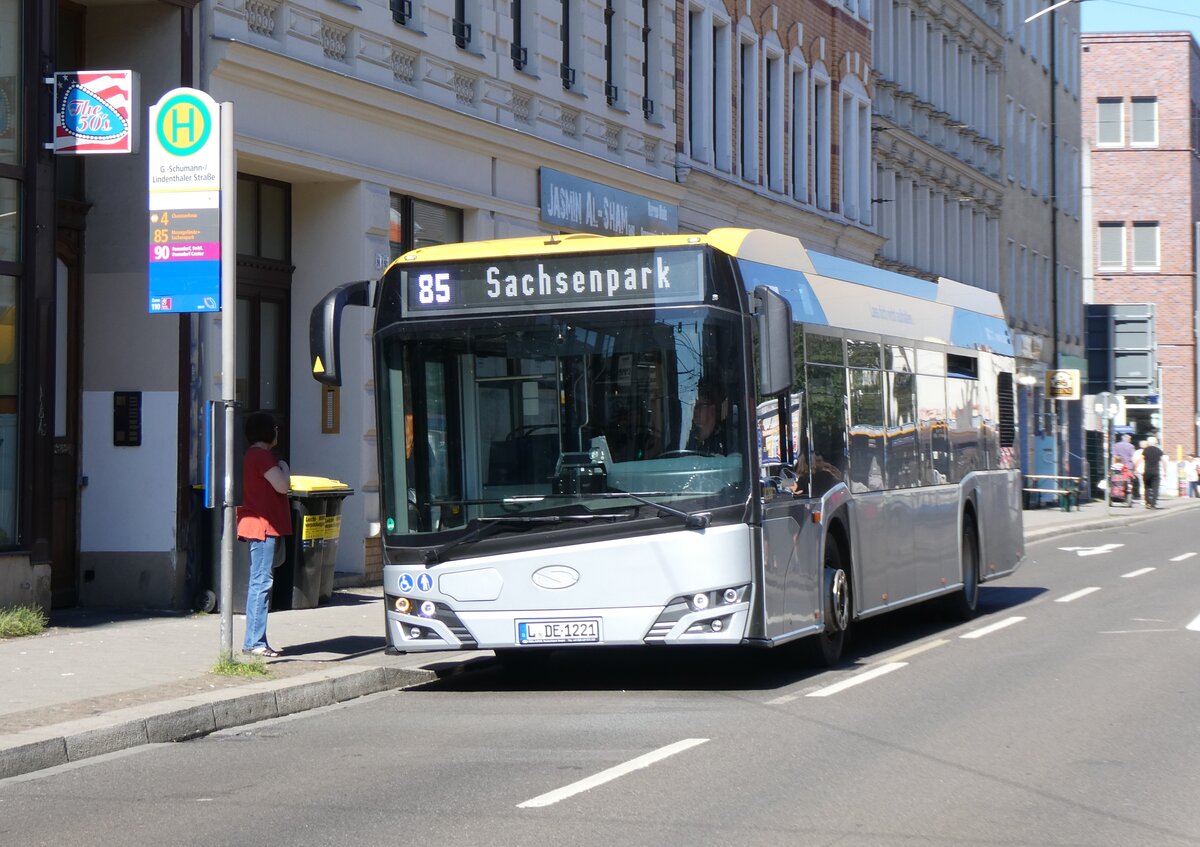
<box><xmin>221</xmin><ymin>103</ymin><xmax>238</xmax><ymax>660</ymax></box>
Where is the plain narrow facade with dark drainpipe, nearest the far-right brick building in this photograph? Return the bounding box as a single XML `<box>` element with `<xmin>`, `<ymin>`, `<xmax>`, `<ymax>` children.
<box><xmin>1000</xmin><ymin>0</ymin><xmax>1086</xmax><ymax>476</ymax></box>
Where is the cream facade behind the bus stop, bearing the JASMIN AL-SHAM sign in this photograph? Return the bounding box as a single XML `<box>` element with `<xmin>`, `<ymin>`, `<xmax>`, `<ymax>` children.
<box><xmin>7</xmin><ymin>0</ymin><xmax>684</xmax><ymax>608</ymax></box>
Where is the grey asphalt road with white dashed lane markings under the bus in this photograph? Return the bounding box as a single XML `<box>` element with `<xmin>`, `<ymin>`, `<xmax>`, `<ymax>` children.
<box><xmin>0</xmin><ymin>513</ymin><xmax>1200</xmax><ymax>847</ymax></box>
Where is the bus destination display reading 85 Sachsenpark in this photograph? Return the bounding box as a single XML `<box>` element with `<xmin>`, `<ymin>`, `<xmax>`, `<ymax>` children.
<box><xmin>400</xmin><ymin>250</ymin><xmax>704</xmax><ymax>316</ymax></box>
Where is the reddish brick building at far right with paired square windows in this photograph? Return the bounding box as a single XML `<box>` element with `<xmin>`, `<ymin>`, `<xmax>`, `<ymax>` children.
<box><xmin>1081</xmin><ymin>32</ymin><xmax>1200</xmax><ymax>456</ymax></box>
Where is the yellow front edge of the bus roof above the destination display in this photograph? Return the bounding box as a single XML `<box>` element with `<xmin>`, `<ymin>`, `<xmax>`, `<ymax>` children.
<box><xmin>396</xmin><ymin>227</ymin><xmax>812</xmax><ymax>272</ymax></box>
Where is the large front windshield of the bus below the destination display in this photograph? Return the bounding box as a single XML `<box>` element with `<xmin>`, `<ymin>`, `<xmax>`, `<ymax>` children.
<box><xmin>376</xmin><ymin>306</ymin><xmax>750</xmax><ymax>543</ymax></box>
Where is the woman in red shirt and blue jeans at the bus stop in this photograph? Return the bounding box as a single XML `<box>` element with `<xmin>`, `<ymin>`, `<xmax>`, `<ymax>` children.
<box><xmin>238</xmin><ymin>412</ymin><xmax>292</xmax><ymax>659</ymax></box>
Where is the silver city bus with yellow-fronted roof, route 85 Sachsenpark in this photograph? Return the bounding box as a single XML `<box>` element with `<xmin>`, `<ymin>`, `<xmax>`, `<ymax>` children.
<box><xmin>311</xmin><ymin>228</ymin><xmax>1025</xmax><ymax>665</ymax></box>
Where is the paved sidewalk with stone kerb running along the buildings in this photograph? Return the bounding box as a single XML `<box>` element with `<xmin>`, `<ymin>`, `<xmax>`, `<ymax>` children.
<box><xmin>0</xmin><ymin>498</ymin><xmax>1200</xmax><ymax>779</ymax></box>
